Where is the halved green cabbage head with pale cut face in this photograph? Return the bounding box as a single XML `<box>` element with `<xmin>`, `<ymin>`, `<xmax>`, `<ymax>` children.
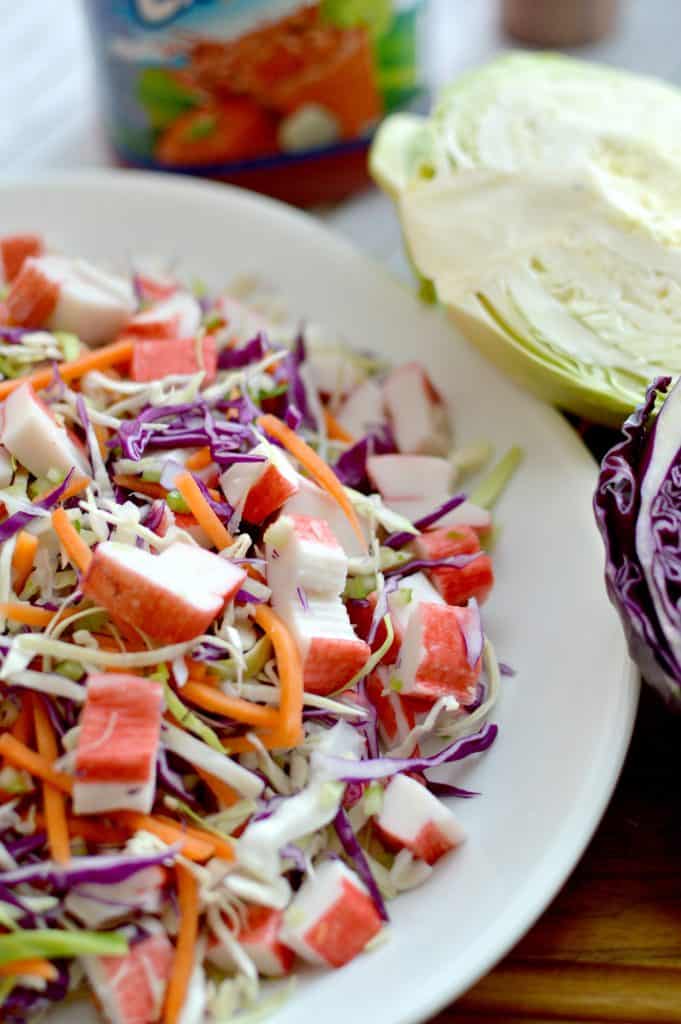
<box><xmin>371</xmin><ymin>53</ymin><xmax>681</xmax><ymax>424</ymax></box>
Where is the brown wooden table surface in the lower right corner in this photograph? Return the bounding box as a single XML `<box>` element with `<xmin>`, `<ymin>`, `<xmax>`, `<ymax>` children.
<box><xmin>431</xmin><ymin>689</ymin><xmax>681</xmax><ymax>1024</ymax></box>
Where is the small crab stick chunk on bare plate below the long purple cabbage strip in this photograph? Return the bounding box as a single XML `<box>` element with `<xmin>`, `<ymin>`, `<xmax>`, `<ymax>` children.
<box><xmin>375</xmin><ymin>775</ymin><xmax>465</xmax><ymax>864</ymax></box>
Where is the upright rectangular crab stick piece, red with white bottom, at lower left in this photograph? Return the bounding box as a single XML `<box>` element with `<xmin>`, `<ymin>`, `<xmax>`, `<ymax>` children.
<box><xmin>74</xmin><ymin>673</ymin><xmax>163</xmax><ymax>814</ymax></box>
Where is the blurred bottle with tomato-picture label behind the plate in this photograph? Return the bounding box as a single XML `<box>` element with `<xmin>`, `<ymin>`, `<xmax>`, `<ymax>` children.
<box><xmin>86</xmin><ymin>0</ymin><xmax>424</xmax><ymax>206</ymax></box>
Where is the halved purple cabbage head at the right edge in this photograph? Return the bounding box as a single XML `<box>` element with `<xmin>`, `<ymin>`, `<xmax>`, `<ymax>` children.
<box><xmin>594</xmin><ymin>377</ymin><xmax>681</xmax><ymax>710</ymax></box>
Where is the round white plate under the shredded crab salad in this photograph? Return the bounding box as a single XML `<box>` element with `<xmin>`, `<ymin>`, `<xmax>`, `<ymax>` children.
<box><xmin>0</xmin><ymin>173</ymin><xmax>638</xmax><ymax>1024</ymax></box>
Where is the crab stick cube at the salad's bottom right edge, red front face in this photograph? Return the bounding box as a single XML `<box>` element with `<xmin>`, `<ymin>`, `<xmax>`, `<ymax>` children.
<box><xmin>282</xmin><ymin>860</ymin><xmax>382</xmax><ymax>967</ymax></box>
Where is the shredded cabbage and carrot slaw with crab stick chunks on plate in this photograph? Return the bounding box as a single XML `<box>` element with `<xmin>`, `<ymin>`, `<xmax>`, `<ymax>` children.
<box><xmin>0</xmin><ymin>236</ymin><xmax>521</xmax><ymax>1024</ymax></box>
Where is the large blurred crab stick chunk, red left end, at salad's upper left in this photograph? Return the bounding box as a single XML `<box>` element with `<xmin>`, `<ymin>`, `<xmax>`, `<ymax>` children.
<box><xmin>7</xmin><ymin>256</ymin><xmax>135</xmax><ymax>345</ymax></box>
